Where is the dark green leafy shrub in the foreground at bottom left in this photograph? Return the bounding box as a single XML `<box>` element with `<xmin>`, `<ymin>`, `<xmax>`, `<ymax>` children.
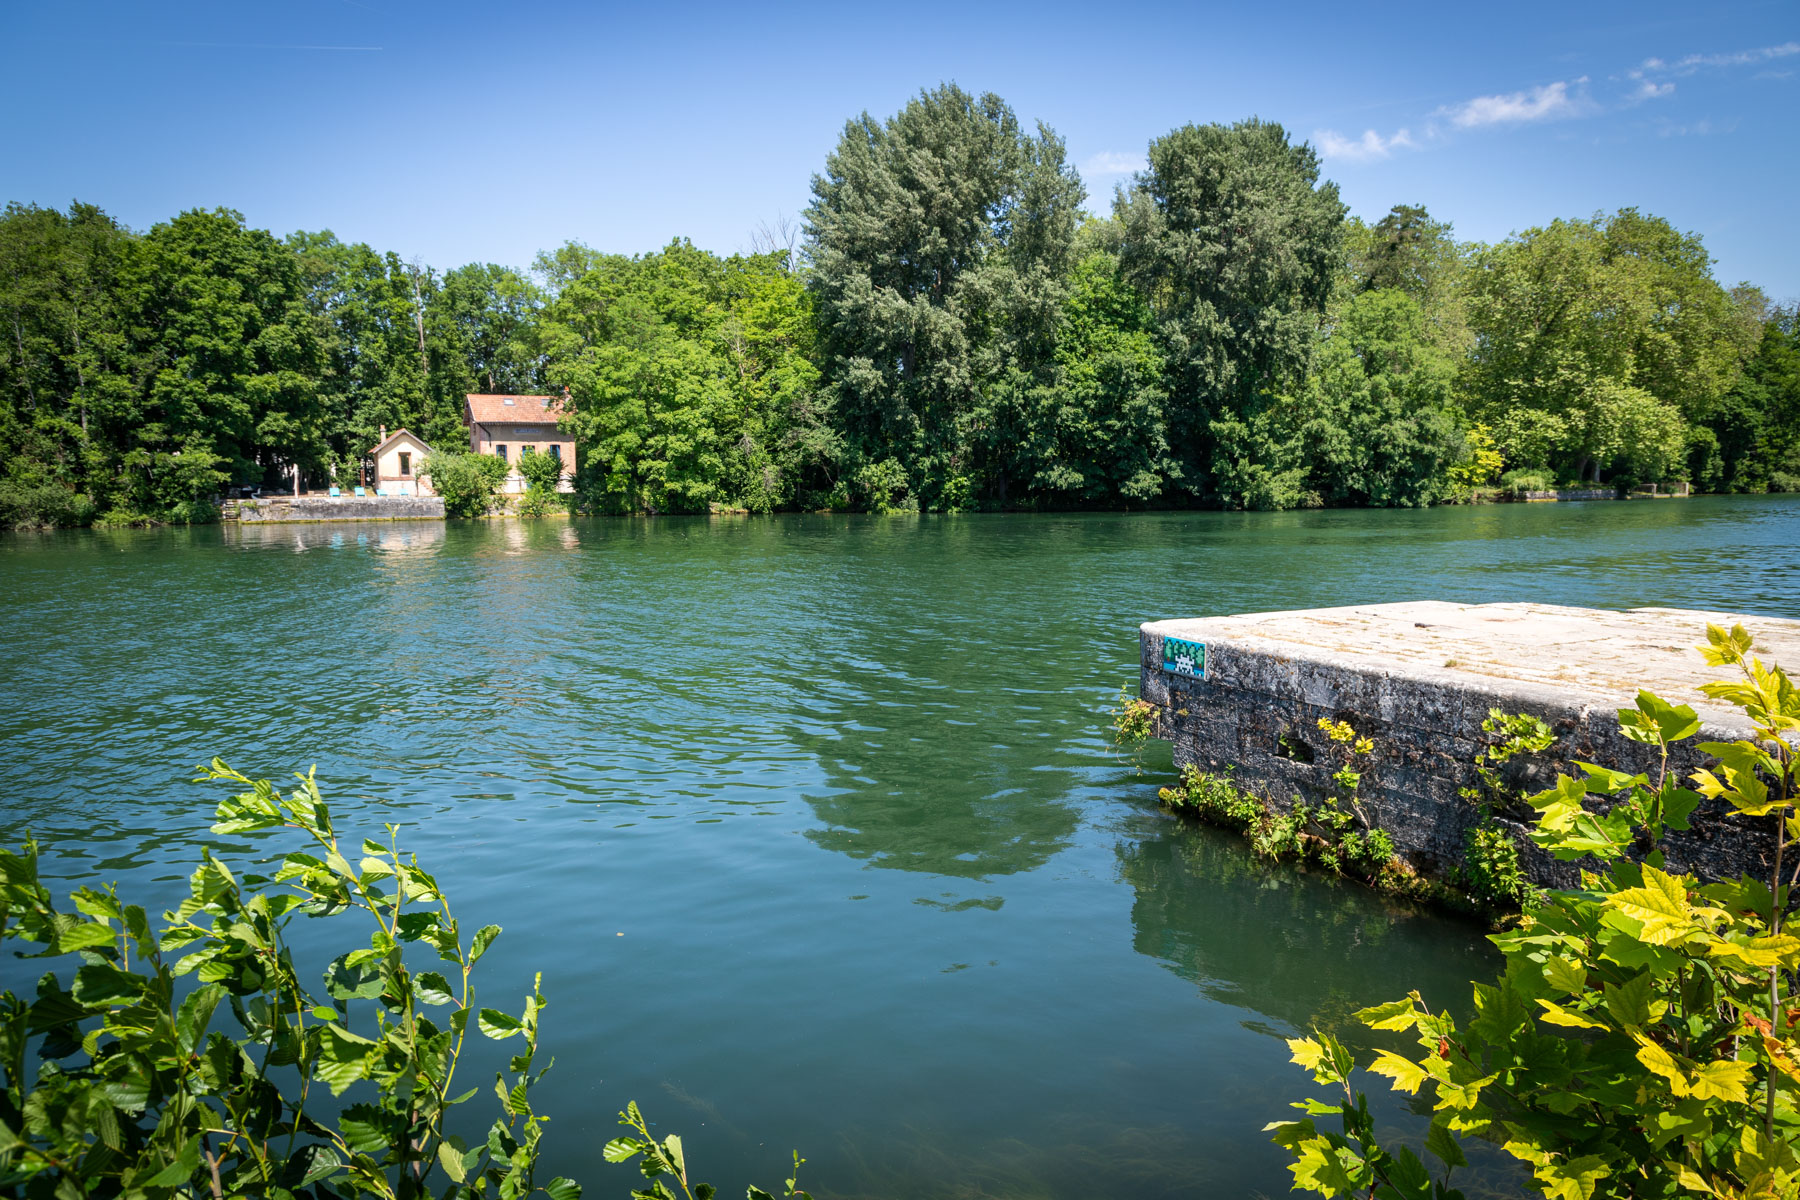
<box><xmin>0</xmin><ymin>759</ymin><xmax>810</xmax><ymax>1200</ymax></box>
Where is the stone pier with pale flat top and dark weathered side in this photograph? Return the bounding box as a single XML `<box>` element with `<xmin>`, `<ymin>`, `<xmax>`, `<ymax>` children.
<box><xmin>1139</xmin><ymin>601</ymin><xmax>1800</xmax><ymax>885</ymax></box>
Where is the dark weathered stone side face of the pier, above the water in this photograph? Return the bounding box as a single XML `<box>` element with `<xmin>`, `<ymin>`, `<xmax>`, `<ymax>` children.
<box><xmin>1139</xmin><ymin>630</ymin><xmax>1775</xmax><ymax>887</ymax></box>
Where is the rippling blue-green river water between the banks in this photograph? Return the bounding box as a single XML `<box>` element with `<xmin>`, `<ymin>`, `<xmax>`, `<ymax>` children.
<box><xmin>0</xmin><ymin>497</ymin><xmax>1800</xmax><ymax>1200</ymax></box>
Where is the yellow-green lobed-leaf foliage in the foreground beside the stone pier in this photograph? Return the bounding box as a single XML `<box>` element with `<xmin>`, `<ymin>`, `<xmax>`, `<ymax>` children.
<box><xmin>1269</xmin><ymin>626</ymin><xmax>1800</xmax><ymax>1200</ymax></box>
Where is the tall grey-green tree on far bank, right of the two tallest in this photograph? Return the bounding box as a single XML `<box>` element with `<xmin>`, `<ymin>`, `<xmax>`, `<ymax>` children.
<box><xmin>1116</xmin><ymin>119</ymin><xmax>1345</xmax><ymax>504</ymax></box>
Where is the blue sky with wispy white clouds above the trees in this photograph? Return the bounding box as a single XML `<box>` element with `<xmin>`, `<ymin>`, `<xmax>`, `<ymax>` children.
<box><xmin>10</xmin><ymin>0</ymin><xmax>1800</xmax><ymax>299</ymax></box>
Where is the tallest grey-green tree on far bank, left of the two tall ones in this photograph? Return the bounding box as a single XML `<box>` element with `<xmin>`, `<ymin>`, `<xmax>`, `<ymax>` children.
<box><xmin>806</xmin><ymin>85</ymin><xmax>1082</xmax><ymax>509</ymax></box>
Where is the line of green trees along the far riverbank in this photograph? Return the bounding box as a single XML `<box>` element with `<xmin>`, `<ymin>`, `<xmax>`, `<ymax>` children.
<box><xmin>0</xmin><ymin>85</ymin><xmax>1800</xmax><ymax>524</ymax></box>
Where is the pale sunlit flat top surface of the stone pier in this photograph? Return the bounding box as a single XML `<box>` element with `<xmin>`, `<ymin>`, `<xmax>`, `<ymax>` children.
<box><xmin>1141</xmin><ymin>601</ymin><xmax>1800</xmax><ymax>725</ymax></box>
